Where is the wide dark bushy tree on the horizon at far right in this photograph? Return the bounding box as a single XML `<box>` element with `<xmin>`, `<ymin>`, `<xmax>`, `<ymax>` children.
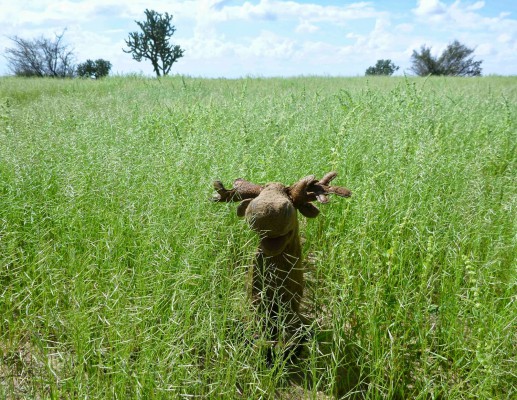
<box><xmin>411</xmin><ymin>40</ymin><xmax>483</xmax><ymax>76</ymax></box>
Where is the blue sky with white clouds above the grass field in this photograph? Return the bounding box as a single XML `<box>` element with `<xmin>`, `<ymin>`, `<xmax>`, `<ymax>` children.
<box><xmin>0</xmin><ymin>0</ymin><xmax>517</xmax><ymax>78</ymax></box>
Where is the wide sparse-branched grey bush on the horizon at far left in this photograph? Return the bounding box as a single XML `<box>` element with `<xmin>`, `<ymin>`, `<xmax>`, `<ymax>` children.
<box><xmin>5</xmin><ymin>31</ymin><xmax>75</xmax><ymax>78</ymax></box>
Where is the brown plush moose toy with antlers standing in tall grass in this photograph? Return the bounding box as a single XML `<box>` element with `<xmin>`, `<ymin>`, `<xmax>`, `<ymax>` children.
<box><xmin>213</xmin><ymin>172</ymin><xmax>352</xmax><ymax>335</ymax></box>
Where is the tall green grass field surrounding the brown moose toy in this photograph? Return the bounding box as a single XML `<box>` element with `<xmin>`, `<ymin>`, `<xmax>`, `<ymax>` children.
<box><xmin>0</xmin><ymin>76</ymin><xmax>517</xmax><ymax>399</ymax></box>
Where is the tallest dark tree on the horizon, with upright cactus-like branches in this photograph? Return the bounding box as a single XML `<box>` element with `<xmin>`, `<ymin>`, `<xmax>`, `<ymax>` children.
<box><xmin>123</xmin><ymin>9</ymin><xmax>185</xmax><ymax>76</ymax></box>
